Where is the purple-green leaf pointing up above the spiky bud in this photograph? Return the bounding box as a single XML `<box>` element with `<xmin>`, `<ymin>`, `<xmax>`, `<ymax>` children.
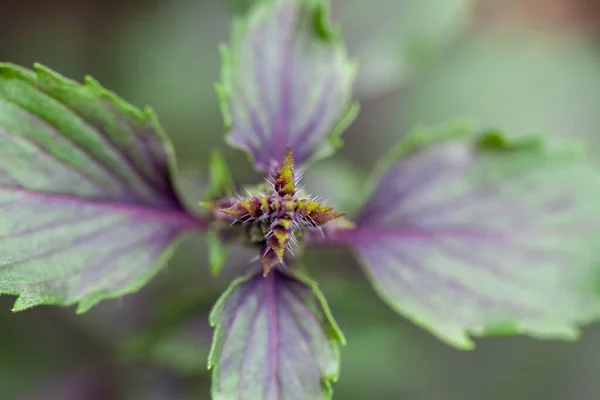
<box><xmin>217</xmin><ymin>0</ymin><xmax>358</xmax><ymax>171</ymax></box>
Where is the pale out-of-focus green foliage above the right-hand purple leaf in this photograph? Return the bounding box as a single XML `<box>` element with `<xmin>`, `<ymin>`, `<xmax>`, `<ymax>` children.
<box><xmin>401</xmin><ymin>32</ymin><xmax>600</xmax><ymax>162</ymax></box>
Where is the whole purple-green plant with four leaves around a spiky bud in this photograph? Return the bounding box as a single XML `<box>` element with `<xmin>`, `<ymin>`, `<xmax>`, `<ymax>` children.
<box><xmin>0</xmin><ymin>0</ymin><xmax>600</xmax><ymax>399</ymax></box>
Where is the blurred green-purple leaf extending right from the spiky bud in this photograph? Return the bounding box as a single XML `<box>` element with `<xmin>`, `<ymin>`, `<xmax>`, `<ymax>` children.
<box><xmin>330</xmin><ymin>126</ymin><xmax>600</xmax><ymax>348</ymax></box>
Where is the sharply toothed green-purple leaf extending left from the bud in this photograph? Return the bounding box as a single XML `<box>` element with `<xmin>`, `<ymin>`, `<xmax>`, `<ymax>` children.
<box><xmin>0</xmin><ymin>64</ymin><xmax>204</xmax><ymax>312</ymax></box>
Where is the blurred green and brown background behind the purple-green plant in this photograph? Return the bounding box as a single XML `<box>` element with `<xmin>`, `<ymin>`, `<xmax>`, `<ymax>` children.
<box><xmin>0</xmin><ymin>0</ymin><xmax>600</xmax><ymax>400</ymax></box>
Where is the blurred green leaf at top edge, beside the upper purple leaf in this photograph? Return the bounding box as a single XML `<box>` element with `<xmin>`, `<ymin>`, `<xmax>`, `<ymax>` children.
<box><xmin>223</xmin><ymin>0</ymin><xmax>474</xmax><ymax>98</ymax></box>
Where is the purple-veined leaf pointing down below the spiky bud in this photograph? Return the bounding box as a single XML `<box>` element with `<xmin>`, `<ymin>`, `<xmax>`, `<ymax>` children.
<box><xmin>208</xmin><ymin>270</ymin><xmax>344</xmax><ymax>400</ymax></box>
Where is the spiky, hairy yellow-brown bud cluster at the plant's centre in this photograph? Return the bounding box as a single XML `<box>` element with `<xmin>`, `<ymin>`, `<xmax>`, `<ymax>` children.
<box><xmin>221</xmin><ymin>149</ymin><xmax>345</xmax><ymax>276</ymax></box>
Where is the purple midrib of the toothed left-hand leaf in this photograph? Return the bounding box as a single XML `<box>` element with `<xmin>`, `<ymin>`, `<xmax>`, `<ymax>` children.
<box><xmin>0</xmin><ymin>187</ymin><xmax>208</xmax><ymax>230</ymax></box>
